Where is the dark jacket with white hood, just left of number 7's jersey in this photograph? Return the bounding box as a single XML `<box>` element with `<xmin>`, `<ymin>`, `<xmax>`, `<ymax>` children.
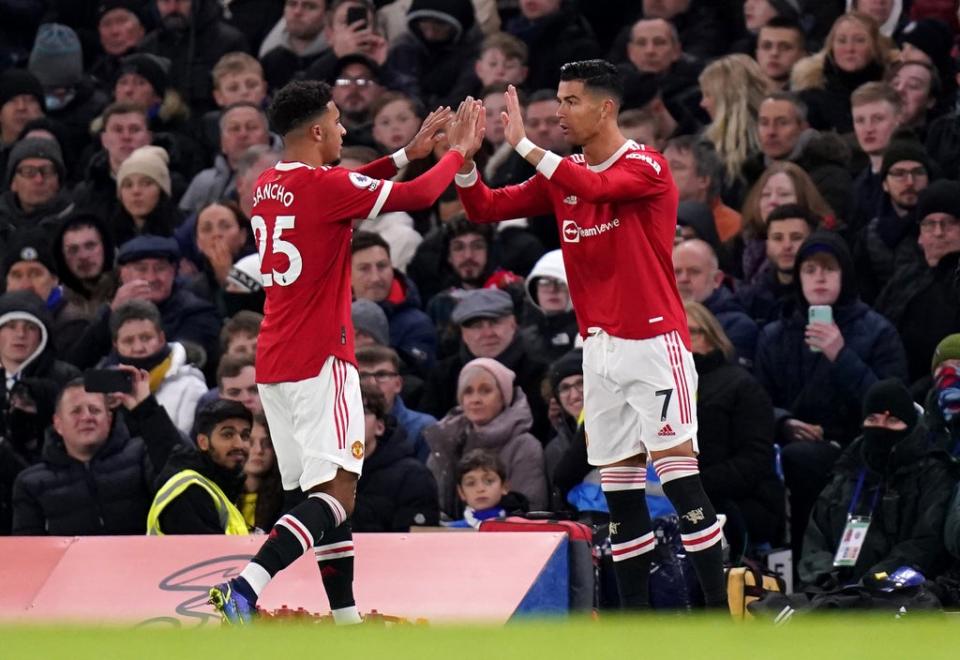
<box><xmin>521</xmin><ymin>250</ymin><xmax>580</xmax><ymax>362</ymax></box>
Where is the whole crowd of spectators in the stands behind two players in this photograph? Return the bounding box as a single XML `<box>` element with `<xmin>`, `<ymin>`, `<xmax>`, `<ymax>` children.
<box><xmin>0</xmin><ymin>0</ymin><xmax>960</xmax><ymax>600</ymax></box>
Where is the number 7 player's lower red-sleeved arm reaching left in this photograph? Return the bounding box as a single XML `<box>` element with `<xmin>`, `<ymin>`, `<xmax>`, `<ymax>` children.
<box><xmin>456</xmin><ymin>160</ymin><xmax>552</xmax><ymax>223</ymax></box>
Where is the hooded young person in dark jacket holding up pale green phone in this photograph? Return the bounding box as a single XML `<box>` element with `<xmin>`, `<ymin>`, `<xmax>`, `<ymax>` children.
<box><xmin>754</xmin><ymin>231</ymin><xmax>907</xmax><ymax>552</ymax></box>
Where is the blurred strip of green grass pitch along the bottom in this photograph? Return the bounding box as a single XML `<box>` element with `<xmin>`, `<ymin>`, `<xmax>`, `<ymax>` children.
<box><xmin>0</xmin><ymin>615</ymin><xmax>960</xmax><ymax>660</ymax></box>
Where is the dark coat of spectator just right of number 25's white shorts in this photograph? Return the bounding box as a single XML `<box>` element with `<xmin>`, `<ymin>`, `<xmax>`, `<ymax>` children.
<box><xmin>351</xmin><ymin>417</ymin><xmax>440</xmax><ymax>532</ymax></box>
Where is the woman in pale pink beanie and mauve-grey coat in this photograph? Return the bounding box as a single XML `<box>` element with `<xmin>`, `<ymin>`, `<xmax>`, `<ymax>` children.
<box><xmin>423</xmin><ymin>358</ymin><xmax>547</xmax><ymax>519</ymax></box>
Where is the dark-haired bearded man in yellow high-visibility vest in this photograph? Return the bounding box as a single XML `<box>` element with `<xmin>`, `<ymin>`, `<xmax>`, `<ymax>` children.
<box><xmin>147</xmin><ymin>400</ymin><xmax>253</xmax><ymax>536</ymax></box>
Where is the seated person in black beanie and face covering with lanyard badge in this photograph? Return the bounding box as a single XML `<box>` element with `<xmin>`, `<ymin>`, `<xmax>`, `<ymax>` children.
<box><xmin>799</xmin><ymin>378</ymin><xmax>956</xmax><ymax>589</ymax></box>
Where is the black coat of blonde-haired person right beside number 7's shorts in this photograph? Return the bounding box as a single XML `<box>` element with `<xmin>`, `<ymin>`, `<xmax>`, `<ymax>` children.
<box><xmin>693</xmin><ymin>351</ymin><xmax>786</xmax><ymax>543</ymax></box>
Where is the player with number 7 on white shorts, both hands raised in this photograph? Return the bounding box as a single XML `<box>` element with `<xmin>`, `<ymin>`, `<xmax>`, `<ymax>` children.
<box><xmin>456</xmin><ymin>60</ymin><xmax>726</xmax><ymax>609</ymax></box>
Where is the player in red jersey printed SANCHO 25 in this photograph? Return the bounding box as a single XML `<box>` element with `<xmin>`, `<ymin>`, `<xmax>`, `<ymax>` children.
<box><xmin>210</xmin><ymin>81</ymin><xmax>484</xmax><ymax>623</ymax></box>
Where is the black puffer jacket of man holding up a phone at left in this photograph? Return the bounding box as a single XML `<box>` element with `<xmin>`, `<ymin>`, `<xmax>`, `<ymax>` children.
<box><xmin>13</xmin><ymin>397</ymin><xmax>180</xmax><ymax>536</ymax></box>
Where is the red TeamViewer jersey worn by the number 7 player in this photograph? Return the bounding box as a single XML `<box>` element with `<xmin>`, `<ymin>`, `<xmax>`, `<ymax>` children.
<box><xmin>457</xmin><ymin>140</ymin><xmax>690</xmax><ymax>348</ymax></box>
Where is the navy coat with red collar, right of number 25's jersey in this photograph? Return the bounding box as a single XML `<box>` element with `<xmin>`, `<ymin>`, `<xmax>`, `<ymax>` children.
<box><xmin>377</xmin><ymin>270</ymin><xmax>437</xmax><ymax>370</ymax></box>
